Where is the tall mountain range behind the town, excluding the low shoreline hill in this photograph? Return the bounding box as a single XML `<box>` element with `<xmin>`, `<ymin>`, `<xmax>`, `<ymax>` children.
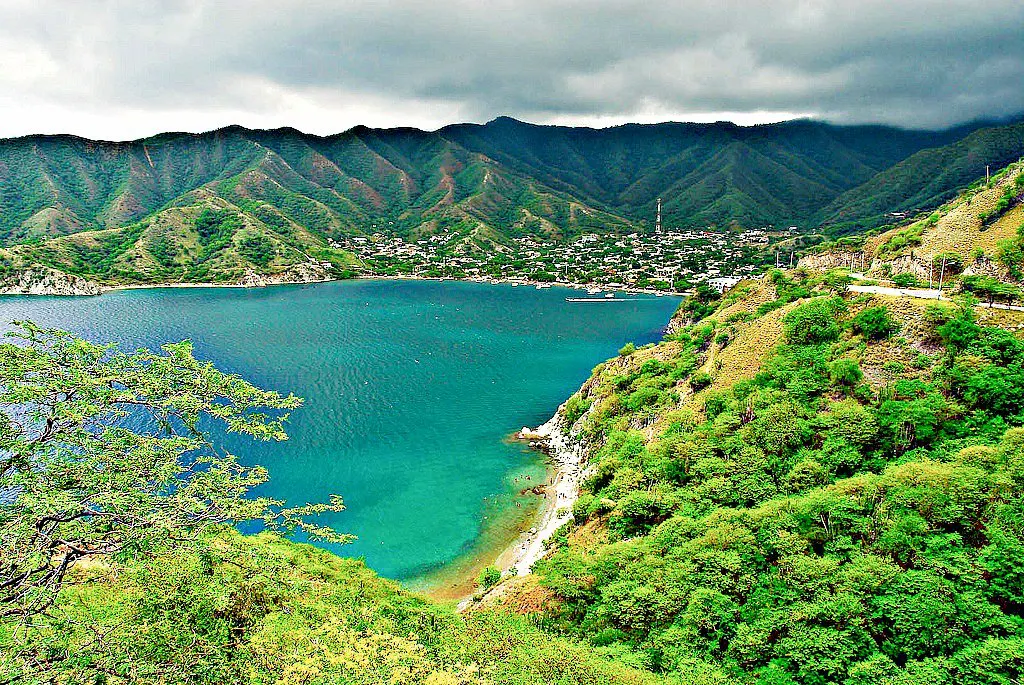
<box><xmin>0</xmin><ymin>118</ymin><xmax>1014</xmax><ymax>253</ymax></box>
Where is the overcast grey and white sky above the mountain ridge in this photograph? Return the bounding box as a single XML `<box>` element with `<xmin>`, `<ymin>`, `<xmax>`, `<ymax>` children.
<box><xmin>0</xmin><ymin>0</ymin><xmax>1024</xmax><ymax>139</ymax></box>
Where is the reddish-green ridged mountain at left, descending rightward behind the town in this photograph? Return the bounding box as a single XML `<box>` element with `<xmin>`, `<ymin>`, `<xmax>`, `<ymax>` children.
<box><xmin>0</xmin><ymin>127</ymin><xmax>627</xmax><ymax>245</ymax></box>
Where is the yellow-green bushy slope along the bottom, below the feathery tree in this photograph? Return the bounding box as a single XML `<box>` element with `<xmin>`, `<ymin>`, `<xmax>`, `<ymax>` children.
<box><xmin>6</xmin><ymin>531</ymin><xmax>664</xmax><ymax>685</ymax></box>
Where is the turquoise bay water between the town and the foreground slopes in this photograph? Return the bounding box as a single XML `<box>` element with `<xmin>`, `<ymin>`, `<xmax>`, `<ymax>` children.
<box><xmin>0</xmin><ymin>281</ymin><xmax>678</xmax><ymax>580</ymax></box>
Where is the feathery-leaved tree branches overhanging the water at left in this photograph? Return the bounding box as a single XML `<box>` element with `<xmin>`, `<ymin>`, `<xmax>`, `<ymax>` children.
<box><xmin>0</xmin><ymin>322</ymin><xmax>351</xmax><ymax>620</ymax></box>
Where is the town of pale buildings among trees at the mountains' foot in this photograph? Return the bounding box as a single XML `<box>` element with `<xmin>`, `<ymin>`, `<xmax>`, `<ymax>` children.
<box><xmin>334</xmin><ymin>229</ymin><xmax>776</xmax><ymax>292</ymax></box>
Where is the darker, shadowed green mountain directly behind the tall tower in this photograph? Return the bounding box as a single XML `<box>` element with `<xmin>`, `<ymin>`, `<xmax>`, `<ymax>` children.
<box><xmin>440</xmin><ymin>118</ymin><xmax>972</xmax><ymax>226</ymax></box>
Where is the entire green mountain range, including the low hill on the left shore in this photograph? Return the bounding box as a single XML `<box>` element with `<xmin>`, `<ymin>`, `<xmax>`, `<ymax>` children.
<box><xmin>0</xmin><ymin>118</ymin><xmax>1024</xmax><ymax>283</ymax></box>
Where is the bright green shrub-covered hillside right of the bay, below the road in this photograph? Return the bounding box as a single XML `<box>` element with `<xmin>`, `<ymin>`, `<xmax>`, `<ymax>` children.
<box><xmin>481</xmin><ymin>271</ymin><xmax>1024</xmax><ymax>685</ymax></box>
